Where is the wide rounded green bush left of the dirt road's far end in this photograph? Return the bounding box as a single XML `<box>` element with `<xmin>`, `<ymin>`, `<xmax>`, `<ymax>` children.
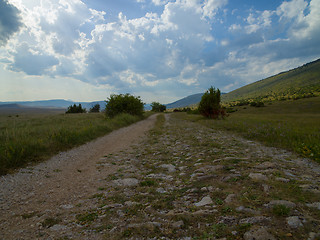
<box><xmin>106</xmin><ymin>93</ymin><xmax>144</xmax><ymax>118</ymax></box>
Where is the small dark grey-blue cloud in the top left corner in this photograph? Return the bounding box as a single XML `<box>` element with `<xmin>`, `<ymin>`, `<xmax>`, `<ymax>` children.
<box><xmin>0</xmin><ymin>0</ymin><xmax>22</xmax><ymax>46</ymax></box>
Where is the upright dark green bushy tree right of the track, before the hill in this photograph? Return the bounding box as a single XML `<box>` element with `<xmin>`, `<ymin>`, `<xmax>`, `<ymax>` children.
<box><xmin>198</xmin><ymin>87</ymin><xmax>225</xmax><ymax>119</ymax></box>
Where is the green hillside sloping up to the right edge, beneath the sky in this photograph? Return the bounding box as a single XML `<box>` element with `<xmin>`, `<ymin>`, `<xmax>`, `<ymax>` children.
<box><xmin>222</xmin><ymin>59</ymin><xmax>320</xmax><ymax>102</ymax></box>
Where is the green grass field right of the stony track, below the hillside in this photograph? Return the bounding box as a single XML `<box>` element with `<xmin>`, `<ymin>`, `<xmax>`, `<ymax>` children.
<box><xmin>181</xmin><ymin>97</ymin><xmax>320</xmax><ymax>163</ymax></box>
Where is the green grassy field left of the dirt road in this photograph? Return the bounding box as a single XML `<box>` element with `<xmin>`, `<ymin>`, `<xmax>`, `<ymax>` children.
<box><xmin>0</xmin><ymin>113</ymin><xmax>151</xmax><ymax>175</ymax></box>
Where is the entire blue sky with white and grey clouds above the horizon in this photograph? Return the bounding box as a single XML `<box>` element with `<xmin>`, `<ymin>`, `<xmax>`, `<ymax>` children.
<box><xmin>0</xmin><ymin>0</ymin><xmax>320</xmax><ymax>104</ymax></box>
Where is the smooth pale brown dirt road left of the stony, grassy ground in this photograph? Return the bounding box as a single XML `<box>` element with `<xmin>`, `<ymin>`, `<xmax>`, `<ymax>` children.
<box><xmin>0</xmin><ymin>115</ymin><xmax>156</xmax><ymax>239</ymax></box>
